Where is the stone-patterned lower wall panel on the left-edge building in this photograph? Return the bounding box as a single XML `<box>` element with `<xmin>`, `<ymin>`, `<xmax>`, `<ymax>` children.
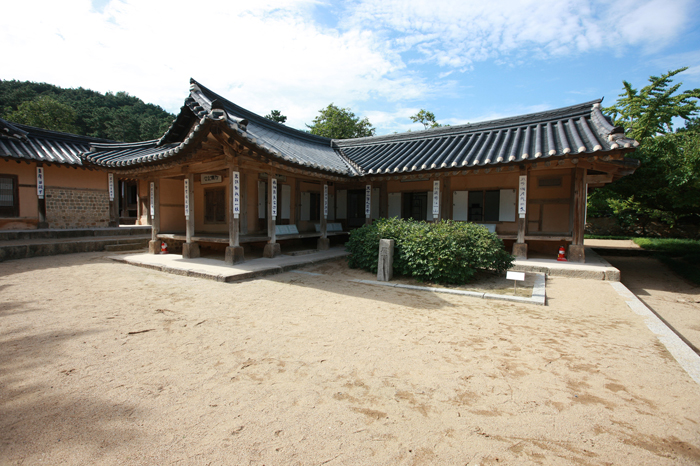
<box><xmin>46</xmin><ymin>187</ymin><xmax>109</xmax><ymax>228</ymax></box>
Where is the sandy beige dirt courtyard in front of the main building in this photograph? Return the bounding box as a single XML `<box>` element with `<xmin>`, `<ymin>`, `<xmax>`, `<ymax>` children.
<box><xmin>0</xmin><ymin>253</ymin><xmax>700</xmax><ymax>466</ymax></box>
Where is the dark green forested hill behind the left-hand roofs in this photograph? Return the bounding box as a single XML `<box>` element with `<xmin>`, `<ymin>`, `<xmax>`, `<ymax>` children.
<box><xmin>0</xmin><ymin>80</ymin><xmax>175</xmax><ymax>142</ymax></box>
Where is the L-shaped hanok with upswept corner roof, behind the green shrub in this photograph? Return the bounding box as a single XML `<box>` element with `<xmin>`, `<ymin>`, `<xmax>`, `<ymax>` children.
<box><xmin>82</xmin><ymin>80</ymin><xmax>638</xmax><ymax>263</ymax></box>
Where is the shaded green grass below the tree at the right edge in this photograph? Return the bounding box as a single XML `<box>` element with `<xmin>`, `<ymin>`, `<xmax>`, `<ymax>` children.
<box><xmin>634</xmin><ymin>238</ymin><xmax>700</xmax><ymax>285</ymax></box>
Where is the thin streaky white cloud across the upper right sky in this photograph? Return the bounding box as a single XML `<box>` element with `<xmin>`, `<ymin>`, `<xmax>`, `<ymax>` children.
<box><xmin>346</xmin><ymin>0</ymin><xmax>694</xmax><ymax>68</ymax></box>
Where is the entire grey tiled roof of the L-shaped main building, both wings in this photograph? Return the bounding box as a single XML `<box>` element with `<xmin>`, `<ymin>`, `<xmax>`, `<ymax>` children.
<box><xmin>83</xmin><ymin>79</ymin><xmax>638</xmax><ymax>176</ymax></box>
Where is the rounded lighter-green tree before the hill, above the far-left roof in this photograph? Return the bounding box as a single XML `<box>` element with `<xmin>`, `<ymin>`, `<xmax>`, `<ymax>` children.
<box><xmin>8</xmin><ymin>95</ymin><xmax>76</xmax><ymax>133</ymax></box>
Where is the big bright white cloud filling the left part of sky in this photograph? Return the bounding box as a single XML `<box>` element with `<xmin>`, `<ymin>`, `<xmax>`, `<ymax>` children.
<box><xmin>0</xmin><ymin>0</ymin><xmax>430</xmax><ymax>127</ymax></box>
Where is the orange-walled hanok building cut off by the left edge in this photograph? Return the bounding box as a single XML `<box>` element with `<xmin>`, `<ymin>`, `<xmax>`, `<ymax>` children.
<box><xmin>0</xmin><ymin>119</ymin><xmax>131</xmax><ymax>230</ymax></box>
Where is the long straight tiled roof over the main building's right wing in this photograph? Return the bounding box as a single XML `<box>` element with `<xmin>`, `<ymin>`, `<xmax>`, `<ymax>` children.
<box><xmin>334</xmin><ymin>99</ymin><xmax>638</xmax><ymax>174</ymax></box>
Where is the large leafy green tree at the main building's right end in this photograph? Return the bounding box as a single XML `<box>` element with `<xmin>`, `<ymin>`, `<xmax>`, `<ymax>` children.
<box><xmin>589</xmin><ymin>68</ymin><xmax>700</xmax><ymax>233</ymax></box>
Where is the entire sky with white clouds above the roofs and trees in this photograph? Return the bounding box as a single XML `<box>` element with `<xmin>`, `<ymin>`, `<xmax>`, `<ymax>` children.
<box><xmin>0</xmin><ymin>0</ymin><xmax>700</xmax><ymax>134</ymax></box>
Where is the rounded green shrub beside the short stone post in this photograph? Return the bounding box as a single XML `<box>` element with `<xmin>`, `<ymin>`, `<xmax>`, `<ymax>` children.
<box><xmin>346</xmin><ymin>218</ymin><xmax>513</xmax><ymax>284</ymax></box>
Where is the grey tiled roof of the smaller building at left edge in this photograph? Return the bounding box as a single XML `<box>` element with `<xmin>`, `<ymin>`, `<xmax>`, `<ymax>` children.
<box><xmin>0</xmin><ymin>119</ymin><xmax>107</xmax><ymax>165</ymax></box>
